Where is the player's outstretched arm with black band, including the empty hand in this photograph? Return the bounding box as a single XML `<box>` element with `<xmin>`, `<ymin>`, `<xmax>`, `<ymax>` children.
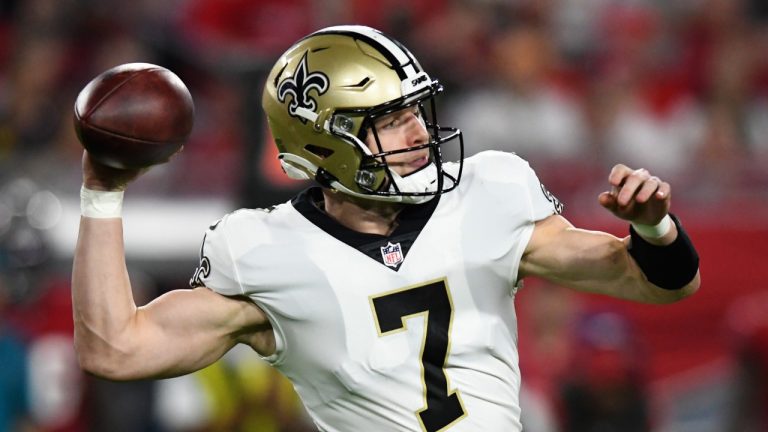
<box><xmin>519</xmin><ymin>165</ymin><xmax>700</xmax><ymax>303</ymax></box>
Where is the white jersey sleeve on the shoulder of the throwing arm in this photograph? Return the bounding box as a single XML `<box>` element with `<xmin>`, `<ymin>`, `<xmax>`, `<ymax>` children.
<box><xmin>189</xmin><ymin>217</ymin><xmax>243</xmax><ymax>295</ymax></box>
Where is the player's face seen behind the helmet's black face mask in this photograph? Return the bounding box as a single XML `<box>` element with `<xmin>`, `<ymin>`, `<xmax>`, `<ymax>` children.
<box><xmin>365</xmin><ymin>106</ymin><xmax>429</xmax><ymax>176</ymax></box>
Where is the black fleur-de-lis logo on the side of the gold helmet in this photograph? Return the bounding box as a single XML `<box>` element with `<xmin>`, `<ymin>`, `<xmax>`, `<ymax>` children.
<box><xmin>277</xmin><ymin>52</ymin><xmax>328</xmax><ymax>123</ymax></box>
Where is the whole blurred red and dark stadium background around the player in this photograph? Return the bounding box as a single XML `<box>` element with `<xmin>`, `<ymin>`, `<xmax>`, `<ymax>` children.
<box><xmin>0</xmin><ymin>0</ymin><xmax>768</xmax><ymax>432</ymax></box>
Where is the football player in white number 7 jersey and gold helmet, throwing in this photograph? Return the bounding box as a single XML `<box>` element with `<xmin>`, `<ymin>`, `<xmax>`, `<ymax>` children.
<box><xmin>73</xmin><ymin>26</ymin><xmax>699</xmax><ymax>432</ymax></box>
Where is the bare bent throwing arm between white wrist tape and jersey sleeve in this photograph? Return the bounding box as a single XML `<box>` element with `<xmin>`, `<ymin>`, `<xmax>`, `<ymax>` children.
<box><xmin>72</xmin><ymin>218</ymin><xmax>269</xmax><ymax>380</ymax></box>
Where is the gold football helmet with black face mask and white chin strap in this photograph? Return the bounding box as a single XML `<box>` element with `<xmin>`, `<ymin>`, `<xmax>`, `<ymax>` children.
<box><xmin>262</xmin><ymin>26</ymin><xmax>464</xmax><ymax>203</ymax></box>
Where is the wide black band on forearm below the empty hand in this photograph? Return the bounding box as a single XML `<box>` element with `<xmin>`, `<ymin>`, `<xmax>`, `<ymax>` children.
<box><xmin>629</xmin><ymin>213</ymin><xmax>699</xmax><ymax>290</ymax></box>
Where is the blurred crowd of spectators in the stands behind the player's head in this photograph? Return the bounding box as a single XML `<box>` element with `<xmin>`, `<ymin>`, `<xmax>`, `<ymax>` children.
<box><xmin>0</xmin><ymin>0</ymin><xmax>768</xmax><ymax>204</ymax></box>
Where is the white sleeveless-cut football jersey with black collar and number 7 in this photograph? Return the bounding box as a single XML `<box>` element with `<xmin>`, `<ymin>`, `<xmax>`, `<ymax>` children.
<box><xmin>192</xmin><ymin>152</ymin><xmax>561</xmax><ymax>432</ymax></box>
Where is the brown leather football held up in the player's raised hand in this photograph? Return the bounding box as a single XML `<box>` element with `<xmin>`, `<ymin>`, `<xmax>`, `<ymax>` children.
<box><xmin>74</xmin><ymin>63</ymin><xmax>195</xmax><ymax>169</ymax></box>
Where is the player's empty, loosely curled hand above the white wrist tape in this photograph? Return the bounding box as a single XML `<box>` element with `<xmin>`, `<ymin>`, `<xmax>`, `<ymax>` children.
<box><xmin>598</xmin><ymin>164</ymin><xmax>672</xmax><ymax>225</ymax></box>
